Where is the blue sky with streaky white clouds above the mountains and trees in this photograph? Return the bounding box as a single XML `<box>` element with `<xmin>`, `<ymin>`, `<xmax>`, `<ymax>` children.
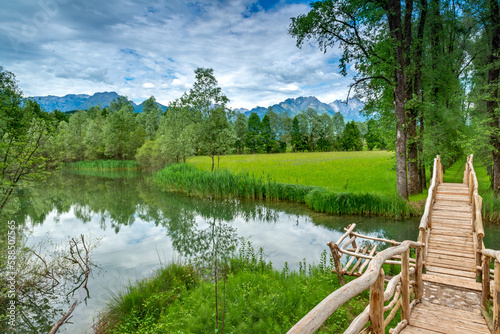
<box><xmin>0</xmin><ymin>0</ymin><xmax>352</xmax><ymax>108</ymax></box>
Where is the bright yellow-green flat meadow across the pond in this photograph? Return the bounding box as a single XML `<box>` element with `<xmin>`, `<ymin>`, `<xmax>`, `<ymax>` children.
<box><xmin>188</xmin><ymin>151</ymin><xmax>397</xmax><ymax>195</ymax></box>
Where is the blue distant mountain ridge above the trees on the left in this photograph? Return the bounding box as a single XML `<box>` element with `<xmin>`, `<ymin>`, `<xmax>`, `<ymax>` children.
<box><xmin>33</xmin><ymin>92</ymin><xmax>167</xmax><ymax>112</ymax></box>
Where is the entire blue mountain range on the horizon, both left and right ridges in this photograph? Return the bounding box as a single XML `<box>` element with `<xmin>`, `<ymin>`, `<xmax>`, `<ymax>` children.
<box><xmin>33</xmin><ymin>92</ymin><xmax>366</xmax><ymax>121</ymax></box>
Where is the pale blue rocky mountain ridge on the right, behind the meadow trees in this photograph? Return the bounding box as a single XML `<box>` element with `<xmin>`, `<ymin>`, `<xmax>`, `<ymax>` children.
<box><xmin>236</xmin><ymin>96</ymin><xmax>366</xmax><ymax>121</ymax></box>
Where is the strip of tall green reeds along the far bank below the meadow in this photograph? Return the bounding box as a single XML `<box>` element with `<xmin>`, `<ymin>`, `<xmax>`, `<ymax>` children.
<box><xmin>150</xmin><ymin>164</ymin><xmax>419</xmax><ymax>218</ymax></box>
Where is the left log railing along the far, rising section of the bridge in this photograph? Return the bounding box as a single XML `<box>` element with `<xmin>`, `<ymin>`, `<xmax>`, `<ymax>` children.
<box><xmin>418</xmin><ymin>155</ymin><xmax>443</xmax><ymax>261</ymax></box>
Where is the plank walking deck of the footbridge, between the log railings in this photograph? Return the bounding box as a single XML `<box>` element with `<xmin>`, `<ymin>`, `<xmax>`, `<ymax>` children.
<box><xmin>401</xmin><ymin>183</ymin><xmax>490</xmax><ymax>334</ymax></box>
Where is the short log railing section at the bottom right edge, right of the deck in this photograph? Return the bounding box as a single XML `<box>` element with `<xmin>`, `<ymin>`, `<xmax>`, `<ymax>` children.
<box><xmin>481</xmin><ymin>249</ymin><xmax>500</xmax><ymax>334</ymax></box>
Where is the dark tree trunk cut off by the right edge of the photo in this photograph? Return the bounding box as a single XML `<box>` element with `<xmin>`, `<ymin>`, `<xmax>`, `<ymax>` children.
<box><xmin>486</xmin><ymin>0</ymin><xmax>500</xmax><ymax>195</ymax></box>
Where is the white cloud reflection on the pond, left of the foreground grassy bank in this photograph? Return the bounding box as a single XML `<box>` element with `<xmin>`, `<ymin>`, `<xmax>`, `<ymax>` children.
<box><xmin>26</xmin><ymin>208</ymin><xmax>177</xmax><ymax>334</ymax></box>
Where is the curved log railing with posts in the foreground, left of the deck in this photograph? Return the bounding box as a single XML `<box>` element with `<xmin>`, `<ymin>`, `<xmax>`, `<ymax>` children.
<box><xmin>288</xmin><ymin>240</ymin><xmax>423</xmax><ymax>334</ymax></box>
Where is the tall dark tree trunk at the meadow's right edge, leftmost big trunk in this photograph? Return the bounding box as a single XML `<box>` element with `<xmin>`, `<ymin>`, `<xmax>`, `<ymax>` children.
<box><xmin>386</xmin><ymin>0</ymin><xmax>408</xmax><ymax>199</ymax></box>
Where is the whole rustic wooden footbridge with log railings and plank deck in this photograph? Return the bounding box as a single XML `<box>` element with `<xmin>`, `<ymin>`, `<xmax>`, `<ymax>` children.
<box><xmin>288</xmin><ymin>155</ymin><xmax>500</xmax><ymax>334</ymax></box>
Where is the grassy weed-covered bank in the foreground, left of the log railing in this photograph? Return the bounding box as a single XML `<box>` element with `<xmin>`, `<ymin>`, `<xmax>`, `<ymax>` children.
<box><xmin>96</xmin><ymin>246</ymin><xmax>368</xmax><ymax>334</ymax></box>
